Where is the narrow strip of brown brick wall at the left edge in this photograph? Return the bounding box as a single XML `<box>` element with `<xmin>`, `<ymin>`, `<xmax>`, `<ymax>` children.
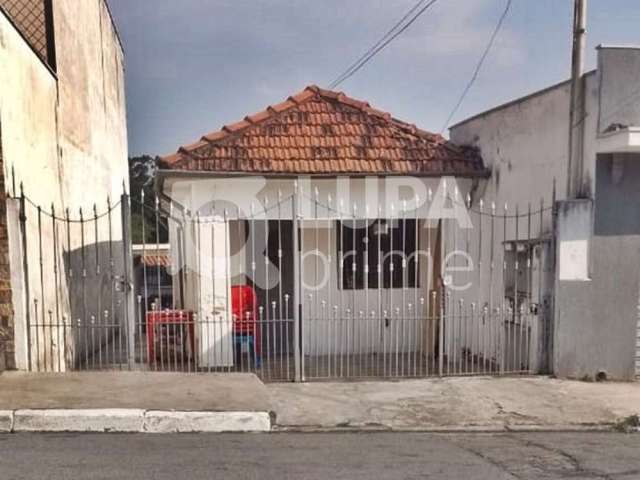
<box><xmin>0</xmin><ymin>124</ymin><xmax>15</xmax><ymax>371</ymax></box>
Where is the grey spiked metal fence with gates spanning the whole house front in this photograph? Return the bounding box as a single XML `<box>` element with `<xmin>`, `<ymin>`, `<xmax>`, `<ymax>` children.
<box><xmin>19</xmin><ymin>180</ymin><xmax>553</xmax><ymax>381</ymax></box>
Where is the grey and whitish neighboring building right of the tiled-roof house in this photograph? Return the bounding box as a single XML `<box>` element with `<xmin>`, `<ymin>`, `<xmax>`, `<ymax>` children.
<box><xmin>451</xmin><ymin>46</ymin><xmax>640</xmax><ymax>380</ymax></box>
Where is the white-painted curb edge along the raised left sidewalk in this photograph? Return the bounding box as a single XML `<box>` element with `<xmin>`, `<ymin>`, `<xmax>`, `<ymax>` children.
<box><xmin>0</xmin><ymin>408</ymin><xmax>272</xmax><ymax>433</ymax></box>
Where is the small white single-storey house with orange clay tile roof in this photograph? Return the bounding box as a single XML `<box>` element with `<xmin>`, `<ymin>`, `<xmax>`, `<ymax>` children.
<box><xmin>158</xmin><ymin>86</ymin><xmax>510</xmax><ymax>380</ymax></box>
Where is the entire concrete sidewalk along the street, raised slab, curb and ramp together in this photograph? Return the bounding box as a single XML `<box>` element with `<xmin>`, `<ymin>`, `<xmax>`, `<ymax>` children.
<box><xmin>0</xmin><ymin>372</ymin><xmax>640</xmax><ymax>433</ymax></box>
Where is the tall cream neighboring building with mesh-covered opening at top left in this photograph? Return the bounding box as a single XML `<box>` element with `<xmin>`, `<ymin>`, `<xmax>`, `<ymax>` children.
<box><xmin>0</xmin><ymin>0</ymin><xmax>128</xmax><ymax>369</ymax></box>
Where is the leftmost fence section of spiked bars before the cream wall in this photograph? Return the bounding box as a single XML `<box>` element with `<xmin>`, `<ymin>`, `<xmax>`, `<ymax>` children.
<box><xmin>18</xmin><ymin>187</ymin><xmax>132</xmax><ymax>371</ymax></box>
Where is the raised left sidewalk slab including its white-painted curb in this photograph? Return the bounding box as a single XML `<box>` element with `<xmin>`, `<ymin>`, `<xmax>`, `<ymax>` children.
<box><xmin>0</xmin><ymin>372</ymin><xmax>272</xmax><ymax>433</ymax></box>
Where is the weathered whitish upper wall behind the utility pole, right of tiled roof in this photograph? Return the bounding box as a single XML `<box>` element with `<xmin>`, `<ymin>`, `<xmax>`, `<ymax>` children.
<box><xmin>450</xmin><ymin>46</ymin><xmax>640</xmax><ymax>232</ymax></box>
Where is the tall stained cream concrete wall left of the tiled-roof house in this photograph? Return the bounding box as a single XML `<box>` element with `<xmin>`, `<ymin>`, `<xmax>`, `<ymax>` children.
<box><xmin>0</xmin><ymin>0</ymin><xmax>128</xmax><ymax>368</ymax></box>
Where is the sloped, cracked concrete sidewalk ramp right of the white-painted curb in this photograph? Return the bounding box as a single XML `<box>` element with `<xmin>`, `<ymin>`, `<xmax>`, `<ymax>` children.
<box><xmin>267</xmin><ymin>377</ymin><xmax>640</xmax><ymax>431</ymax></box>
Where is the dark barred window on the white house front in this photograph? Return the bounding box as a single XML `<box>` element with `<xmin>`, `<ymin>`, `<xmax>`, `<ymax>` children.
<box><xmin>337</xmin><ymin>219</ymin><xmax>418</xmax><ymax>290</ymax></box>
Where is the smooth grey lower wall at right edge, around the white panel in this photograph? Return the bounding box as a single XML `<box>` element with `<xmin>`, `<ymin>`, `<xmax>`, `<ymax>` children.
<box><xmin>554</xmin><ymin>155</ymin><xmax>640</xmax><ymax>380</ymax></box>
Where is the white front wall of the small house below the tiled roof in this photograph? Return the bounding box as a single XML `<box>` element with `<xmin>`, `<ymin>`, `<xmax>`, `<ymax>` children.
<box><xmin>163</xmin><ymin>176</ymin><xmax>473</xmax><ymax>355</ymax></box>
